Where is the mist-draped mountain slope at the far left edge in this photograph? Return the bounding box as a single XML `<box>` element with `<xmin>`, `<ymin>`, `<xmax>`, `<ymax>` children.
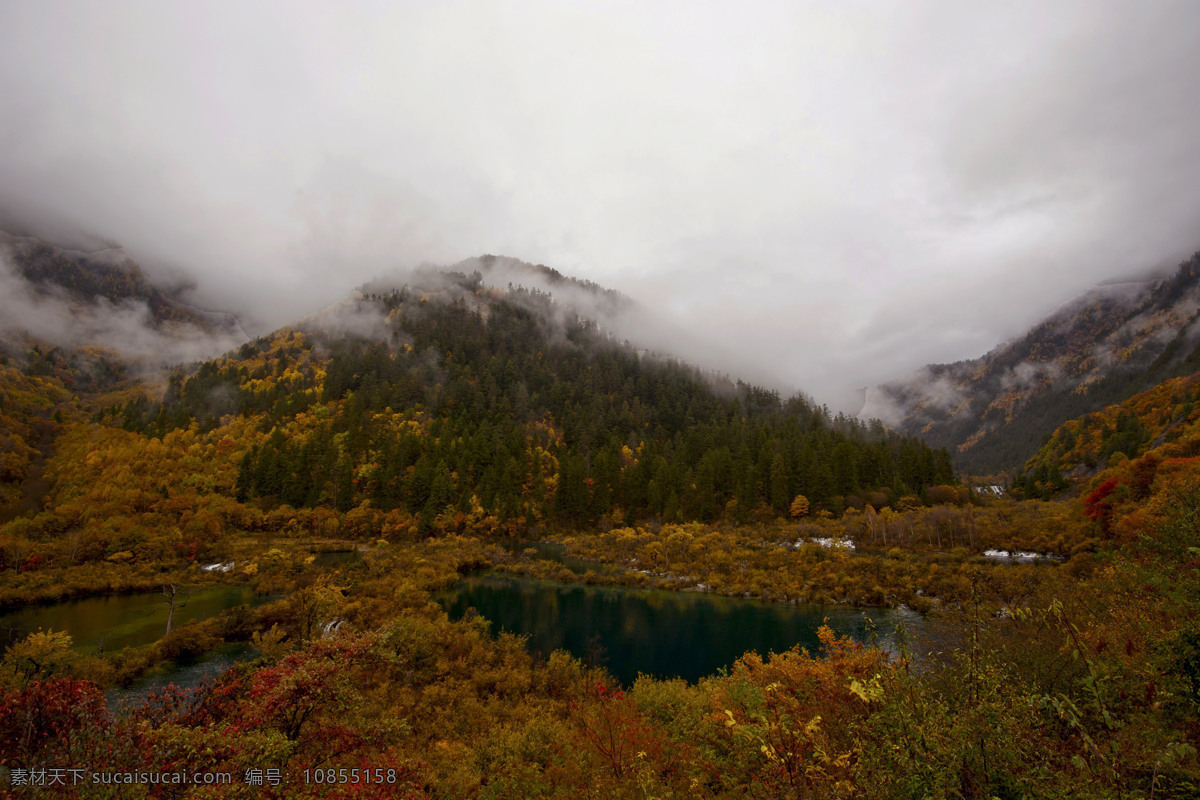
<box><xmin>0</xmin><ymin>231</ymin><xmax>245</xmax><ymax>523</ymax></box>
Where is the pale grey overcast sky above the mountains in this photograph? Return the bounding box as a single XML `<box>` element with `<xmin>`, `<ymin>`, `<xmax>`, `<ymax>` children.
<box><xmin>0</xmin><ymin>0</ymin><xmax>1200</xmax><ymax>410</ymax></box>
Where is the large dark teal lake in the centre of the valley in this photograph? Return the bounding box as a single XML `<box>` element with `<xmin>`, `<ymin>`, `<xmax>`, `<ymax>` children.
<box><xmin>438</xmin><ymin>573</ymin><xmax>922</xmax><ymax>685</ymax></box>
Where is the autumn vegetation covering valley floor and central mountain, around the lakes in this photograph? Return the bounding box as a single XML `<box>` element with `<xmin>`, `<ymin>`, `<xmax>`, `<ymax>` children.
<box><xmin>0</xmin><ymin>261</ymin><xmax>1200</xmax><ymax>800</ymax></box>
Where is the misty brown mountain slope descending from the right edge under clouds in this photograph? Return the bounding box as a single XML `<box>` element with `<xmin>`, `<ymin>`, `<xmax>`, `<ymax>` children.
<box><xmin>863</xmin><ymin>253</ymin><xmax>1200</xmax><ymax>473</ymax></box>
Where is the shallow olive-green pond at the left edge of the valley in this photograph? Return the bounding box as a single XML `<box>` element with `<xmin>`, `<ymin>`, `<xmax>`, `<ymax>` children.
<box><xmin>0</xmin><ymin>585</ymin><xmax>270</xmax><ymax>652</ymax></box>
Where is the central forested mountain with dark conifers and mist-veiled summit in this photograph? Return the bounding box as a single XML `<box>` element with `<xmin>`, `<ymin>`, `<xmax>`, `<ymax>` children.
<box><xmin>110</xmin><ymin>267</ymin><xmax>953</xmax><ymax>530</ymax></box>
